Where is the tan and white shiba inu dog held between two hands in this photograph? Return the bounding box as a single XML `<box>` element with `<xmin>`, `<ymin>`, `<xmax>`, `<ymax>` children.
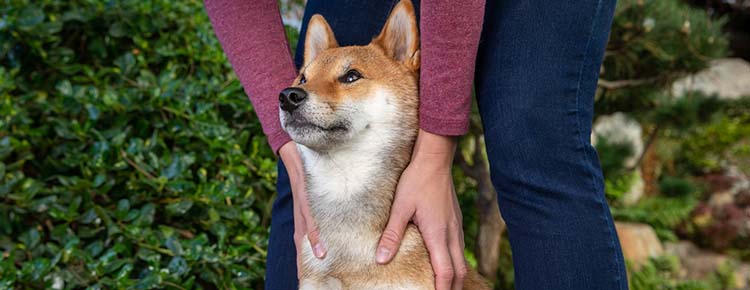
<box><xmin>279</xmin><ymin>0</ymin><xmax>489</xmax><ymax>290</ymax></box>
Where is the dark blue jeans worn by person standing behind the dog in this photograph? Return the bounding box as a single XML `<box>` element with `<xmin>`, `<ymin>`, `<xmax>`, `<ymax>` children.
<box><xmin>266</xmin><ymin>0</ymin><xmax>628</xmax><ymax>290</ymax></box>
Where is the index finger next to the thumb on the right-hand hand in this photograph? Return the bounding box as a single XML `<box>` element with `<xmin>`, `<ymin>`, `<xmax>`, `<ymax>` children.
<box><xmin>423</xmin><ymin>228</ymin><xmax>454</xmax><ymax>290</ymax></box>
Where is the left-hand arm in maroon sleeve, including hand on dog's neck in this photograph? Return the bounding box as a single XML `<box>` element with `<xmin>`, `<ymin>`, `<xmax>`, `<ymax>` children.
<box><xmin>204</xmin><ymin>0</ymin><xmax>326</xmax><ymax>268</ymax></box>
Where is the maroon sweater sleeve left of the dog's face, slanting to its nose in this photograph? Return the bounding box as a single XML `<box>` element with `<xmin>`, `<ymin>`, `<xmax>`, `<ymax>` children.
<box><xmin>204</xmin><ymin>0</ymin><xmax>296</xmax><ymax>152</ymax></box>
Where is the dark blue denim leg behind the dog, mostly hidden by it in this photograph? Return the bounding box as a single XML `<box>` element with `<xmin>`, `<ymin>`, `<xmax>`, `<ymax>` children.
<box><xmin>265</xmin><ymin>0</ymin><xmax>419</xmax><ymax>290</ymax></box>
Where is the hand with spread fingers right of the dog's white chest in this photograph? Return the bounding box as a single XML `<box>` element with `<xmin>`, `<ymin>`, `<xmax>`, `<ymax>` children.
<box><xmin>376</xmin><ymin>130</ymin><xmax>467</xmax><ymax>290</ymax></box>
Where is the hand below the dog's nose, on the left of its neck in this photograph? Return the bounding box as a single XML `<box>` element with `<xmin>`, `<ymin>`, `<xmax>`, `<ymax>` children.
<box><xmin>279</xmin><ymin>141</ymin><xmax>326</xmax><ymax>276</ymax></box>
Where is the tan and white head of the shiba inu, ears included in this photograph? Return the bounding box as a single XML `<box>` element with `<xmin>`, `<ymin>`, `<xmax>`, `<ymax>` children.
<box><xmin>279</xmin><ymin>0</ymin><xmax>419</xmax><ymax>152</ymax></box>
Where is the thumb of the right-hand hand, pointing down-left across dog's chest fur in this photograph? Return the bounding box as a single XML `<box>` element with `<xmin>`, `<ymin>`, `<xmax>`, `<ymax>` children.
<box><xmin>375</xmin><ymin>206</ymin><xmax>414</xmax><ymax>264</ymax></box>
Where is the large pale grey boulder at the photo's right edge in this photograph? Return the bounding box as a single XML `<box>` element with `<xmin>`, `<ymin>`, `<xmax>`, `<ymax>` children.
<box><xmin>672</xmin><ymin>58</ymin><xmax>750</xmax><ymax>100</ymax></box>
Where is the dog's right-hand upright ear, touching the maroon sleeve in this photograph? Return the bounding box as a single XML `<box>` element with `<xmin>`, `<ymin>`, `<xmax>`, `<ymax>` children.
<box><xmin>372</xmin><ymin>0</ymin><xmax>419</xmax><ymax>70</ymax></box>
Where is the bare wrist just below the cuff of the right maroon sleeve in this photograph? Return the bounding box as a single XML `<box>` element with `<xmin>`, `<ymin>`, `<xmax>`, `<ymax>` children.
<box><xmin>411</xmin><ymin>129</ymin><xmax>456</xmax><ymax>168</ymax></box>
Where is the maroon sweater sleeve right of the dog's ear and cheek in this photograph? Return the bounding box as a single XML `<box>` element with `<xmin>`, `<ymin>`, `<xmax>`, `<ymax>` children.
<box><xmin>419</xmin><ymin>0</ymin><xmax>485</xmax><ymax>136</ymax></box>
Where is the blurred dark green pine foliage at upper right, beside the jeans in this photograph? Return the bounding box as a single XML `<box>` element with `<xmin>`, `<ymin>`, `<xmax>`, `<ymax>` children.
<box><xmin>595</xmin><ymin>0</ymin><xmax>728</xmax><ymax>116</ymax></box>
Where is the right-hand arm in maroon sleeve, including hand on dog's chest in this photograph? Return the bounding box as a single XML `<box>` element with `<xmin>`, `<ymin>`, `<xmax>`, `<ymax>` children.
<box><xmin>376</xmin><ymin>0</ymin><xmax>484</xmax><ymax>290</ymax></box>
